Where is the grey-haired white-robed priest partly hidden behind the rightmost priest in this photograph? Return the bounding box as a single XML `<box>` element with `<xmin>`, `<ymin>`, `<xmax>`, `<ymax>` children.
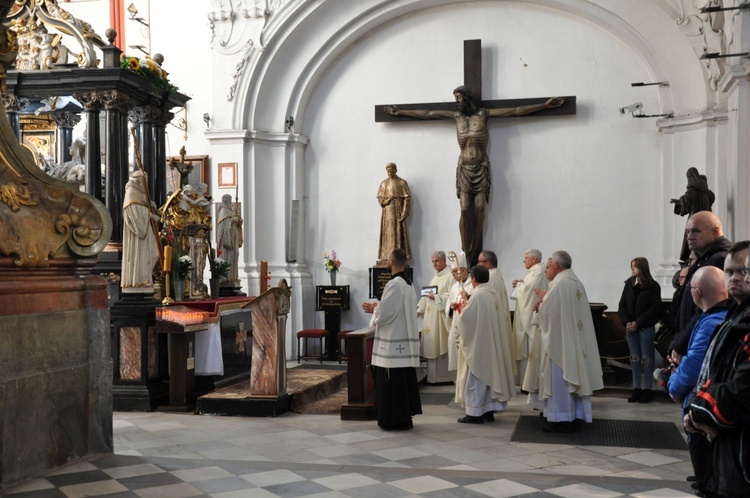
<box><xmin>511</xmin><ymin>249</ymin><xmax>547</xmax><ymax>393</ymax></box>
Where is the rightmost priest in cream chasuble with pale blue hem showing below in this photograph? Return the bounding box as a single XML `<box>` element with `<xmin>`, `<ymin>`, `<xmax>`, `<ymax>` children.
<box><xmin>537</xmin><ymin>251</ymin><xmax>604</xmax><ymax>432</ymax></box>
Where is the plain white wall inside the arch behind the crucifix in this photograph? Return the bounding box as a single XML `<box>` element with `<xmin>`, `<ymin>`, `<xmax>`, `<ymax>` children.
<box><xmin>296</xmin><ymin>3</ymin><xmax>684</xmax><ymax>325</ymax></box>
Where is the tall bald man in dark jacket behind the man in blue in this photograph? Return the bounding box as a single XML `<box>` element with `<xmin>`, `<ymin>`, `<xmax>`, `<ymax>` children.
<box><xmin>672</xmin><ymin>211</ymin><xmax>732</xmax><ymax>362</ymax></box>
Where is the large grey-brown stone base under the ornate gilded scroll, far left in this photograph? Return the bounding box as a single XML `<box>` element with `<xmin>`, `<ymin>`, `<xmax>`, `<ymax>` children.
<box><xmin>0</xmin><ymin>257</ymin><xmax>113</xmax><ymax>494</ymax></box>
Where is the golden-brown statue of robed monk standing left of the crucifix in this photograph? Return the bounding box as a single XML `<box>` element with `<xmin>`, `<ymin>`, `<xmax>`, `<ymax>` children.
<box><xmin>377</xmin><ymin>163</ymin><xmax>411</xmax><ymax>266</ymax></box>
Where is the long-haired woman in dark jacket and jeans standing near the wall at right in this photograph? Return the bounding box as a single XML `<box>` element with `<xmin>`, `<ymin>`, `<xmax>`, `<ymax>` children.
<box><xmin>619</xmin><ymin>258</ymin><xmax>661</xmax><ymax>403</ymax></box>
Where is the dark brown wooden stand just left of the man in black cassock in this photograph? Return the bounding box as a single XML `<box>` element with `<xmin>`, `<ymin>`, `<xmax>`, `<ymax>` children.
<box><xmin>341</xmin><ymin>327</ymin><xmax>375</xmax><ymax>420</ymax></box>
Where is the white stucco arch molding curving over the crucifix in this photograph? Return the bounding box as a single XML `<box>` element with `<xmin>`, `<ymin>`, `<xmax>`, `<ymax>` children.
<box><xmin>228</xmin><ymin>0</ymin><xmax>713</xmax><ymax>133</ymax></box>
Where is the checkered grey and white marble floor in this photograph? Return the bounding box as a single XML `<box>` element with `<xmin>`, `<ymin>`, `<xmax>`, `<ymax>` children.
<box><xmin>4</xmin><ymin>376</ymin><xmax>694</xmax><ymax>498</ymax></box>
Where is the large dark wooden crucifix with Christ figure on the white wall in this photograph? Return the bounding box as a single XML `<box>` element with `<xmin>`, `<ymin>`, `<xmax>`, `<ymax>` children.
<box><xmin>375</xmin><ymin>40</ymin><xmax>576</xmax><ymax>266</ymax></box>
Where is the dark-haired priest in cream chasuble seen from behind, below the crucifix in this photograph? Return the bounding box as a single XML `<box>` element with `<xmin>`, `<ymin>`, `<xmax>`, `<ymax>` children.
<box><xmin>455</xmin><ymin>266</ymin><xmax>516</xmax><ymax>424</ymax></box>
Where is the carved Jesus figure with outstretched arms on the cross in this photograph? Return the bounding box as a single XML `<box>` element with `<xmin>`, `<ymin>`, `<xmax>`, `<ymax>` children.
<box><xmin>383</xmin><ymin>86</ymin><xmax>565</xmax><ymax>264</ymax></box>
